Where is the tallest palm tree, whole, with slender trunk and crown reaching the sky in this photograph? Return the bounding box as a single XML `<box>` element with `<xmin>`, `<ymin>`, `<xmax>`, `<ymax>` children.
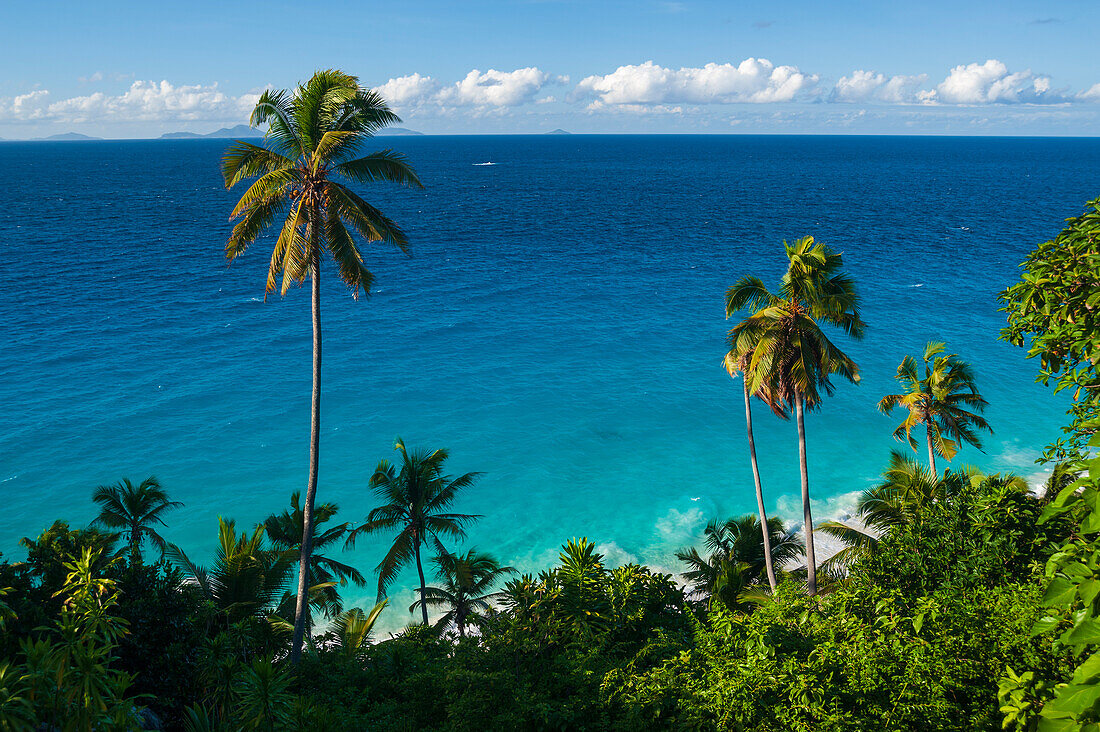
<box><xmin>222</xmin><ymin>70</ymin><xmax>421</xmax><ymax>663</ymax></box>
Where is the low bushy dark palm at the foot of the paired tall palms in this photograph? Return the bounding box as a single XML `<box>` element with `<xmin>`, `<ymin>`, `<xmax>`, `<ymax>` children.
<box><xmin>675</xmin><ymin>514</ymin><xmax>803</xmax><ymax>599</ymax></box>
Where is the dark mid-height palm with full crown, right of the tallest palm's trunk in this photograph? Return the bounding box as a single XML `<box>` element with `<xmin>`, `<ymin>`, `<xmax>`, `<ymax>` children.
<box><xmin>348</xmin><ymin>437</ymin><xmax>480</xmax><ymax>625</ymax></box>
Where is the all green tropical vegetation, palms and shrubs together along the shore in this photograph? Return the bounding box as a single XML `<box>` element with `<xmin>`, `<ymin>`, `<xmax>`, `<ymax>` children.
<box><xmin>0</xmin><ymin>72</ymin><xmax>1100</xmax><ymax>732</ymax></box>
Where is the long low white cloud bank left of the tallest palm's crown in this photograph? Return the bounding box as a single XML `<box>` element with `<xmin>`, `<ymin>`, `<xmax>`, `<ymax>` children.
<box><xmin>0</xmin><ymin>81</ymin><xmax>260</xmax><ymax>122</ymax></box>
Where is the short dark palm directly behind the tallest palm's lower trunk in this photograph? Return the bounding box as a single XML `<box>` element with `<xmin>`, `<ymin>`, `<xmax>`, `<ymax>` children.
<box><xmin>264</xmin><ymin>491</ymin><xmax>366</xmax><ymax>625</ymax></box>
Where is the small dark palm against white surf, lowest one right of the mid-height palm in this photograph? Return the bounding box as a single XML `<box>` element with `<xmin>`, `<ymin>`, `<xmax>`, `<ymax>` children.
<box><xmin>409</xmin><ymin>549</ymin><xmax>516</xmax><ymax>637</ymax></box>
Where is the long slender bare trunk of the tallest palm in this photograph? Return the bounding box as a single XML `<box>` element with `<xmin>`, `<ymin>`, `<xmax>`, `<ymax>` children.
<box><xmin>290</xmin><ymin>249</ymin><xmax>321</xmax><ymax>664</ymax></box>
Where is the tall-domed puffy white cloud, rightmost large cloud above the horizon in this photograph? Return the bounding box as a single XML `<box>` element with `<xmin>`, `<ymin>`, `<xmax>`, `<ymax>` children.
<box><xmin>927</xmin><ymin>58</ymin><xmax>1067</xmax><ymax>105</ymax></box>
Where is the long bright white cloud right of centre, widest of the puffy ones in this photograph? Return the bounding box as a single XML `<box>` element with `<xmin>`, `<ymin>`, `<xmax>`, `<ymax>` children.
<box><xmin>574</xmin><ymin>58</ymin><xmax>818</xmax><ymax>105</ymax></box>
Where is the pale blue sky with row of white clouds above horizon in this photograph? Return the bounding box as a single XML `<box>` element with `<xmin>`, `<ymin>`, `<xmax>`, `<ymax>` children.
<box><xmin>0</xmin><ymin>0</ymin><xmax>1100</xmax><ymax>140</ymax></box>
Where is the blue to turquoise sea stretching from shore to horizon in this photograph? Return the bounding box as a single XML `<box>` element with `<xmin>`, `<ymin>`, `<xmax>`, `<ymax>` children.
<box><xmin>0</xmin><ymin>135</ymin><xmax>1100</xmax><ymax>626</ymax></box>
